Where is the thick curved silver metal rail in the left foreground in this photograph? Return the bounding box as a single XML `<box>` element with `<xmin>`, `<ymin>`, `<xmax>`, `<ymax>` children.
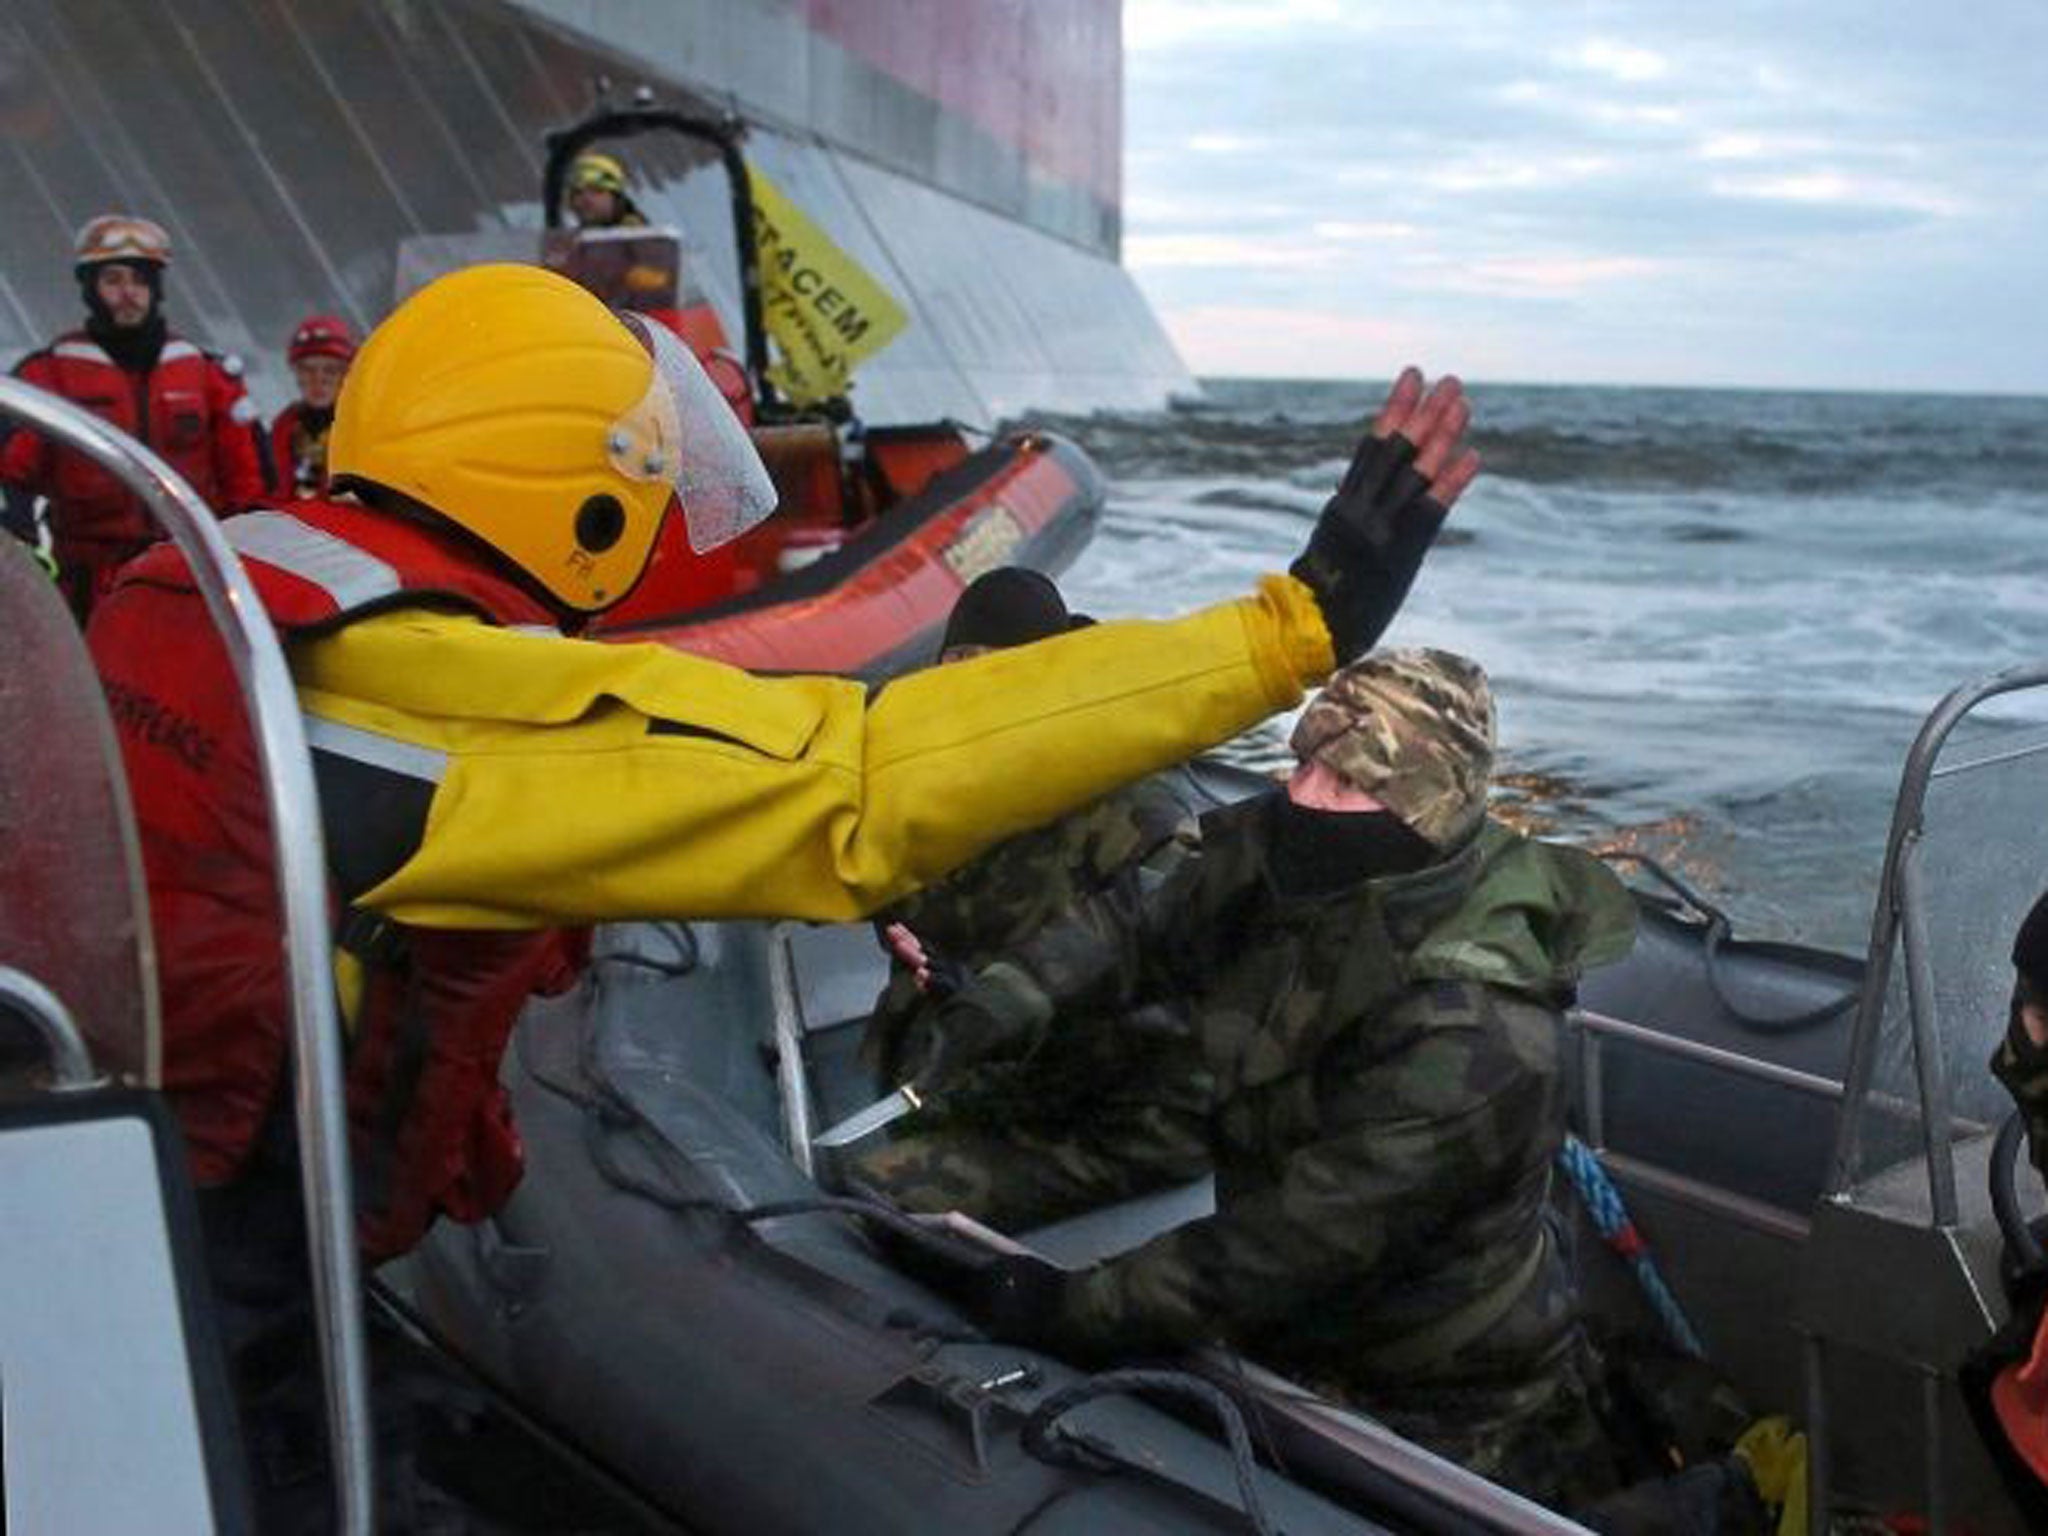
<box><xmin>0</xmin><ymin>377</ymin><xmax>375</xmax><ymax>1536</ymax></box>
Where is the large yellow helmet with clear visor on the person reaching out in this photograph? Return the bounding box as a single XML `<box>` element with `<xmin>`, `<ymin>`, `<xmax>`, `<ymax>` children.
<box><xmin>328</xmin><ymin>264</ymin><xmax>774</xmax><ymax>612</ymax></box>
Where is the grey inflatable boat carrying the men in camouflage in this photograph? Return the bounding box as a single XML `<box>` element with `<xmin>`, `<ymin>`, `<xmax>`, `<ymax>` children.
<box><xmin>403</xmin><ymin>696</ymin><xmax>2048</xmax><ymax>1532</ymax></box>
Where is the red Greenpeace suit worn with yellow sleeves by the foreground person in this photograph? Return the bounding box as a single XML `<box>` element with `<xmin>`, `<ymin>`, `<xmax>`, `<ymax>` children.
<box><xmin>88</xmin><ymin>502</ymin><xmax>584</xmax><ymax>1260</ymax></box>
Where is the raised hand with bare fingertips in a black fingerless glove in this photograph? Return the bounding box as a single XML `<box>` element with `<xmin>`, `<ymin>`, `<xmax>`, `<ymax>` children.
<box><xmin>1288</xmin><ymin>369</ymin><xmax>1479</xmax><ymax>666</ymax></box>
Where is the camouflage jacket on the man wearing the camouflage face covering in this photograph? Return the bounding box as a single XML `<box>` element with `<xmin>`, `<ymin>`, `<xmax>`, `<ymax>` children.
<box><xmin>977</xmin><ymin>797</ymin><xmax>1634</xmax><ymax>1393</ymax></box>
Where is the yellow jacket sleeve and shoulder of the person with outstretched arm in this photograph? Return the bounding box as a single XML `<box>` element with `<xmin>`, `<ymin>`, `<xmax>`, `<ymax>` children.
<box><xmin>291</xmin><ymin>575</ymin><xmax>1331</xmax><ymax>928</ymax></box>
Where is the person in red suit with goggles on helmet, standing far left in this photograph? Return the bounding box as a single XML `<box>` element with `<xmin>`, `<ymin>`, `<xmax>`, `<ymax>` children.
<box><xmin>0</xmin><ymin>213</ymin><xmax>264</xmax><ymax>623</ymax></box>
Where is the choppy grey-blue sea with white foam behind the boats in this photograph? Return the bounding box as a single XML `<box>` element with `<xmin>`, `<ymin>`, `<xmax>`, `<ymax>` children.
<box><xmin>1032</xmin><ymin>379</ymin><xmax>2048</xmax><ymax>950</ymax></box>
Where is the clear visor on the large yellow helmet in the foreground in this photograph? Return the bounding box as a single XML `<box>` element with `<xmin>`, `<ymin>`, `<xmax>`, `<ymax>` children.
<box><xmin>606</xmin><ymin>313</ymin><xmax>776</xmax><ymax>555</ymax></box>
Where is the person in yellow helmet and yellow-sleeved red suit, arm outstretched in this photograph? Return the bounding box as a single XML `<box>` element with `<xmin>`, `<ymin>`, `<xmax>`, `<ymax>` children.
<box><xmin>88</xmin><ymin>266</ymin><xmax>1477</xmax><ymax>1531</ymax></box>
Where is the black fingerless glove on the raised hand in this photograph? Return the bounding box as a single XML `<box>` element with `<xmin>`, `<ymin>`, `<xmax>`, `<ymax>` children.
<box><xmin>1288</xmin><ymin>423</ymin><xmax>1448</xmax><ymax>666</ymax></box>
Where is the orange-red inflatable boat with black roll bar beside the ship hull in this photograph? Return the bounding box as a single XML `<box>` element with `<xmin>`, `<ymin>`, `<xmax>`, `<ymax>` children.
<box><xmin>397</xmin><ymin>102</ymin><xmax>1106</xmax><ymax>678</ymax></box>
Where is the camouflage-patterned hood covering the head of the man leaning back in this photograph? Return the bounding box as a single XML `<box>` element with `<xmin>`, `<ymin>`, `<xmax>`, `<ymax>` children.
<box><xmin>1290</xmin><ymin>647</ymin><xmax>1493</xmax><ymax>848</ymax></box>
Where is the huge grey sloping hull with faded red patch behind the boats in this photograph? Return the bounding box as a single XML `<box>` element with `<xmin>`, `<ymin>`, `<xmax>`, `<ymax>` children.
<box><xmin>0</xmin><ymin>0</ymin><xmax>1192</xmax><ymax>426</ymax></box>
